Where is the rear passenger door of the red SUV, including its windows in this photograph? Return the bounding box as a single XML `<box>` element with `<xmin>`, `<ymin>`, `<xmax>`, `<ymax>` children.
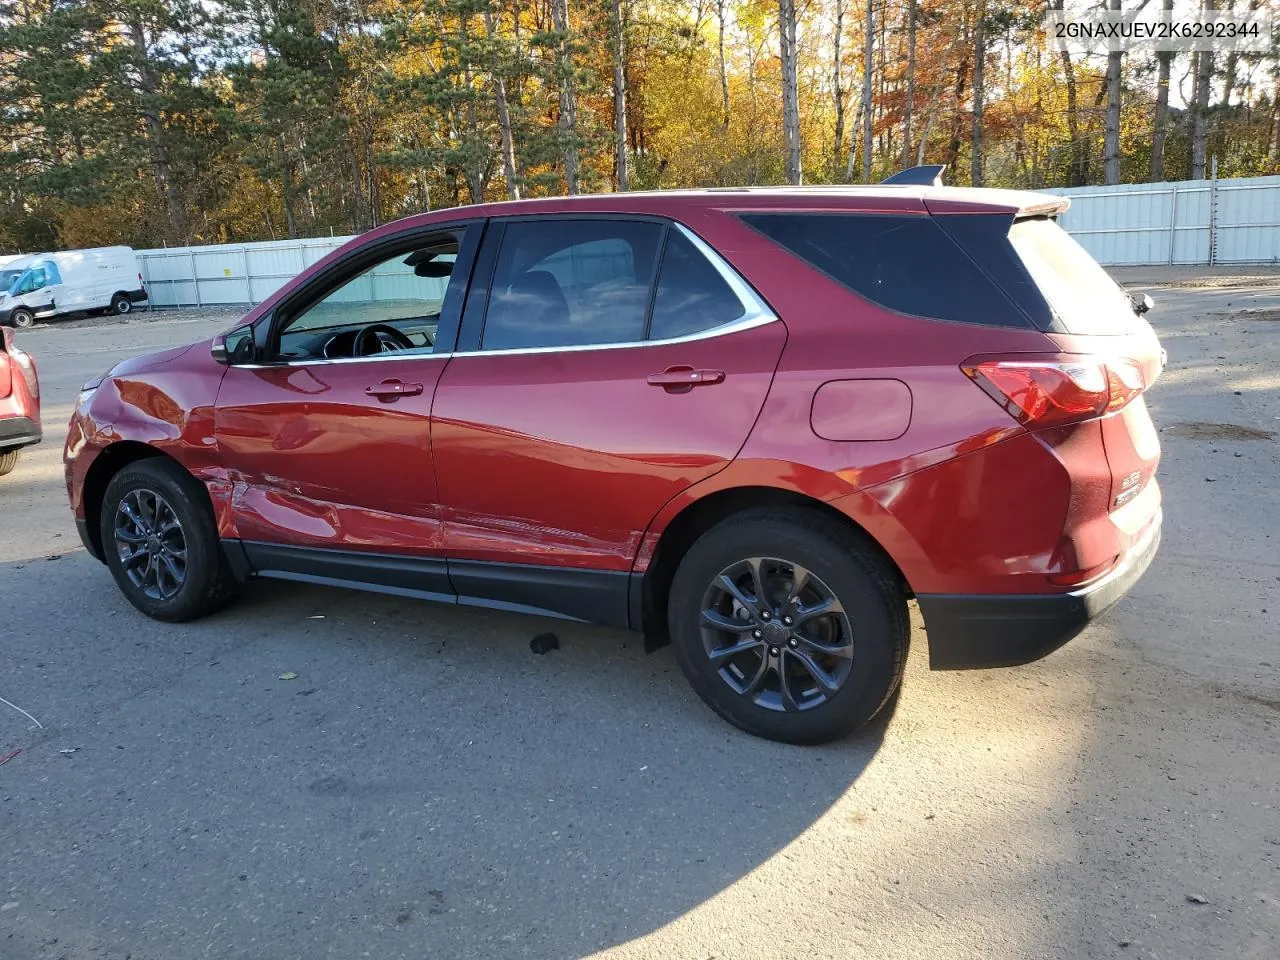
<box><xmin>431</xmin><ymin>218</ymin><xmax>786</xmax><ymax>591</ymax></box>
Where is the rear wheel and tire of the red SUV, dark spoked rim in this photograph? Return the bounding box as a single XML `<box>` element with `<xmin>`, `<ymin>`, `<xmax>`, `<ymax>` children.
<box><xmin>668</xmin><ymin>508</ymin><xmax>910</xmax><ymax>744</ymax></box>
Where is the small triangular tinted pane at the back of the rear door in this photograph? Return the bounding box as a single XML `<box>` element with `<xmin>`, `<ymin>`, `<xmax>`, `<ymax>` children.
<box><xmin>649</xmin><ymin>229</ymin><xmax>746</xmax><ymax>340</ymax></box>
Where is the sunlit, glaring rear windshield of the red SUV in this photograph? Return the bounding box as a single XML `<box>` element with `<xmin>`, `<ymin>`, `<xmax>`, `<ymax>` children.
<box><xmin>1009</xmin><ymin>218</ymin><xmax>1142</xmax><ymax>334</ymax></box>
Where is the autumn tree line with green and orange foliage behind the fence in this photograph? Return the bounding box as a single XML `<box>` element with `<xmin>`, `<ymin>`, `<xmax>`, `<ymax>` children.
<box><xmin>0</xmin><ymin>0</ymin><xmax>1280</xmax><ymax>251</ymax></box>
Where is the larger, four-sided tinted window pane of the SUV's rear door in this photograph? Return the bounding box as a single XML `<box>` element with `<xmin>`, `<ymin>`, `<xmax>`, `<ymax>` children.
<box><xmin>480</xmin><ymin>219</ymin><xmax>664</xmax><ymax>349</ymax></box>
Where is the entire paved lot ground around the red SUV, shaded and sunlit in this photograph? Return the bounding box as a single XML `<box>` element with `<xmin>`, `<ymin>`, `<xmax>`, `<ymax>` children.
<box><xmin>0</xmin><ymin>280</ymin><xmax>1280</xmax><ymax>960</ymax></box>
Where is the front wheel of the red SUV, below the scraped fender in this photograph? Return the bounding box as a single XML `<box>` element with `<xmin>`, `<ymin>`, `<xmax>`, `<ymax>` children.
<box><xmin>99</xmin><ymin>457</ymin><xmax>237</xmax><ymax>623</ymax></box>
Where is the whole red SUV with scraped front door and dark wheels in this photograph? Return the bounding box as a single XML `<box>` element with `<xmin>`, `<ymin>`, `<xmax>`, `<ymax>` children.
<box><xmin>65</xmin><ymin>176</ymin><xmax>1162</xmax><ymax>742</ymax></box>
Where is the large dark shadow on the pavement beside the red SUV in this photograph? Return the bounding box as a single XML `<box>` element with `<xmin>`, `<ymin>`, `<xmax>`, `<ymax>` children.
<box><xmin>0</xmin><ymin>553</ymin><xmax>892</xmax><ymax>960</ymax></box>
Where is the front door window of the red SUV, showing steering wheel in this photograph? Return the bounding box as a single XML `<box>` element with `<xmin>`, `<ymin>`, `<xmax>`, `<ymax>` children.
<box><xmin>276</xmin><ymin>236</ymin><xmax>466</xmax><ymax>361</ymax></box>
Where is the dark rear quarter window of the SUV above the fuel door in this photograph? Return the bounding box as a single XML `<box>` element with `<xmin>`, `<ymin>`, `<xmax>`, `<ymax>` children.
<box><xmin>742</xmin><ymin>214</ymin><xmax>1033</xmax><ymax>328</ymax></box>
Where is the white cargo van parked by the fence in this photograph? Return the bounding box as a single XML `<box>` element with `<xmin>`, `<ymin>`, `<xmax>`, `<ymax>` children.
<box><xmin>0</xmin><ymin>247</ymin><xmax>147</xmax><ymax>326</ymax></box>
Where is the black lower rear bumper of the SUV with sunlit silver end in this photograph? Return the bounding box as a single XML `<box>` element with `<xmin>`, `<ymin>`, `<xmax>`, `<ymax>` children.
<box><xmin>916</xmin><ymin>513</ymin><xmax>1162</xmax><ymax>669</ymax></box>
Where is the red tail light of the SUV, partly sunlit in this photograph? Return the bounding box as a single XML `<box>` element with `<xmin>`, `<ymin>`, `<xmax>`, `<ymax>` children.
<box><xmin>960</xmin><ymin>355</ymin><xmax>1147</xmax><ymax>429</ymax></box>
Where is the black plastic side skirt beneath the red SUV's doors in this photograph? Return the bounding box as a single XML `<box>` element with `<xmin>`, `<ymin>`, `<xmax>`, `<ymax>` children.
<box><xmin>223</xmin><ymin>540</ymin><xmax>630</xmax><ymax>630</ymax></box>
